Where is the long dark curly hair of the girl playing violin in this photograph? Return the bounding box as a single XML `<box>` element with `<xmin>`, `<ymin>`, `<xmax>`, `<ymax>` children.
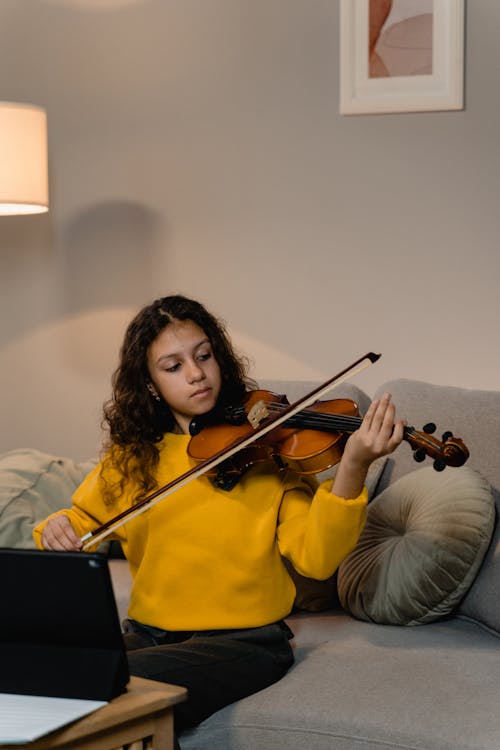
<box><xmin>100</xmin><ymin>295</ymin><xmax>254</xmax><ymax>504</ymax></box>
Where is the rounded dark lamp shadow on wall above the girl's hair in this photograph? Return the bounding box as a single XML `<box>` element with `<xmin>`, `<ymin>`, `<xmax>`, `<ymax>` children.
<box><xmin>62</xmin><ymin>201</ymin><xmax>161</xmax><ymax>313</ymax></box>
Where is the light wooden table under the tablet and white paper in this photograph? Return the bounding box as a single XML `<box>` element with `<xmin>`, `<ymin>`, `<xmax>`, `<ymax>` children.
<box><xmin>0</xmin><ymin>677</ymin><xmax>187</xmax><ymax>750</ymax></box>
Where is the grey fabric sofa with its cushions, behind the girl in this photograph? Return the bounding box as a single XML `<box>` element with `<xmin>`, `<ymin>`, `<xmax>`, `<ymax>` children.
<box><xmin>0</xmin><ymin>380</ymin><xmax>500</xmax><ymax>750</ymax></box>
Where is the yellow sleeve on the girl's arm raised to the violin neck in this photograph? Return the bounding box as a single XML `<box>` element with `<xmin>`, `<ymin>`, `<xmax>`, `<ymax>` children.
<box><xmin>278</xmin><ymin>479</ymin><xmax>368</xmax><ymax>580</ymax></box>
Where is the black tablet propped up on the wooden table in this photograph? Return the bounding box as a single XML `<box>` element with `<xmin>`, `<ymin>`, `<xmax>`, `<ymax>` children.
<box><xmin>0</xmin><ymin>548</ymin><xmax>129</xmax><ymax>701</ymax></box>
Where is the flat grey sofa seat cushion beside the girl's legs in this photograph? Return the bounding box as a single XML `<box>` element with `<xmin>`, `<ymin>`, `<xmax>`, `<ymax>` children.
<box><xmin>180</xmin><ymin>612</ymin><xmax>500</xmax><ymax>750</ymax></box>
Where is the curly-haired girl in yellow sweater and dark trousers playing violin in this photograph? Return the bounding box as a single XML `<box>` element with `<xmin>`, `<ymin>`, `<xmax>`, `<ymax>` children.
<box><xmin>34</xmin><ymin>295</ymin><xmax>403</xmax><ymax>732</ymax></box>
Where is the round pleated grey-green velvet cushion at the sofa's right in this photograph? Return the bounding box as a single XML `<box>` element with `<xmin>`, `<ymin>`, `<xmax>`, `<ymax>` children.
<box><xmin>338</xmin><ymin>466</ymin><xmax>495</xmax><ymax>625</ymax></box>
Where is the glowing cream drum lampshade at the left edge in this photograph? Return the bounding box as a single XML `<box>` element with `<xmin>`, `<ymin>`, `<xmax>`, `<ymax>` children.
<box><xmin>0</xmin><ymin>102</ymin><xmax>49</xmax><ymax>215</ymax></box>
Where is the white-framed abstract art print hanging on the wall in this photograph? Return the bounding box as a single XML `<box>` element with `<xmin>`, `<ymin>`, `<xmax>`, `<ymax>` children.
<box><xmin>340</xmin><ymin>0</ymin><xmax>465</xmax><ymax>115</ymax></box>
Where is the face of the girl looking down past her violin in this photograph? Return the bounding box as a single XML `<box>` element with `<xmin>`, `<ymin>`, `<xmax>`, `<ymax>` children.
<box><xmin>147</xmin><ymin>320</ymin><xmax>221</xmax><ymax>433</ymax></box>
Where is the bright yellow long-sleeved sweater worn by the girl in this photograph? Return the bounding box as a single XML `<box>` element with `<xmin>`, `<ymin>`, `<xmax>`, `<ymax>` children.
<box><xmin>33</xmin><ymin>433</ymin><xmax>367</xmax><ymax>630</ymax></box>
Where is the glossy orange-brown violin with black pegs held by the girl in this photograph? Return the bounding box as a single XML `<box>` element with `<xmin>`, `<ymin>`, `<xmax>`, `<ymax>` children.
<box><xmin>188</xmin><ymin>390</ymin><xmax>469</xmax><ymax>490</ymax></box>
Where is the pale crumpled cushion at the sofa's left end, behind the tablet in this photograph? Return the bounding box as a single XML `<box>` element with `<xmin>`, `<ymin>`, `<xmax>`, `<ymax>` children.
<box><xmin>0</xmin><ymin>449</ymin><xmax>95</xmax><ymax>548</ymax></box>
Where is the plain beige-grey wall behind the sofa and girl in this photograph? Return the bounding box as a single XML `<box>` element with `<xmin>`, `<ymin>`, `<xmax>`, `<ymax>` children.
<box><xmin>0</xmin><ymin>0</ymin><xmax>500</xmax><ymax>458</ymax></box>
